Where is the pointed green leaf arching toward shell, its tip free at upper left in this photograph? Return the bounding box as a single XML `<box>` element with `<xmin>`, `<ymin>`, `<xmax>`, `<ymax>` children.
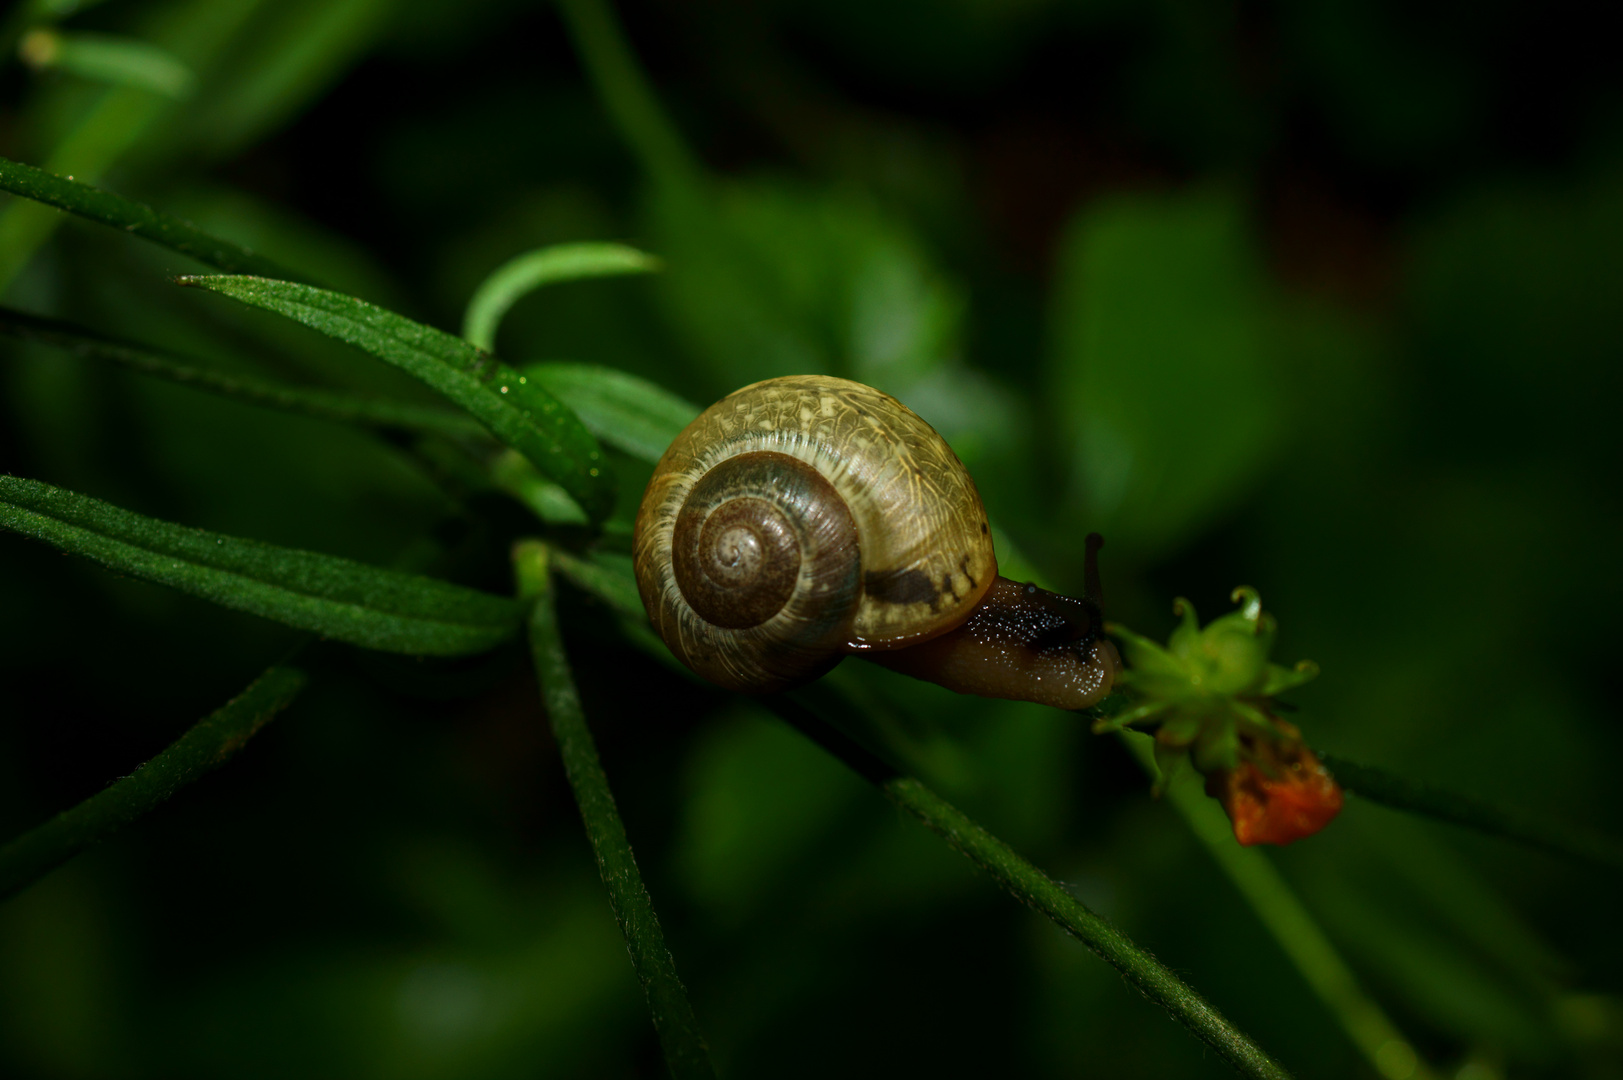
<box><xmin>179</xmin><ymin>274</ymin><xmax>615</xmax><ymax>523</ymax></box>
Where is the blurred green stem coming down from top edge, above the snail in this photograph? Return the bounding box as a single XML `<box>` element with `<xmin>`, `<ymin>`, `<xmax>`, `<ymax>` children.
<box><xmin>558</xmin><ymin>0</ymin><xmax>703</xmax><ymax>193</ymax></box>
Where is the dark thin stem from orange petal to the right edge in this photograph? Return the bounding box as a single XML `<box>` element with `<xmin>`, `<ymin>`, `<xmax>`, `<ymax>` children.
<box><xmin>1319</xmin><ymin>754</ymin><xmax>1623</xmax><ymax>869</ymax></box>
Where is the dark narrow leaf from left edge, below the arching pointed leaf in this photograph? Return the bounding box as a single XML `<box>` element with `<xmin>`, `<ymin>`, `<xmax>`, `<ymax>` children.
<box><xmin>0</xmin><ymin>307</ymin><xmax>484</xmax><ymax>435</ymax></box>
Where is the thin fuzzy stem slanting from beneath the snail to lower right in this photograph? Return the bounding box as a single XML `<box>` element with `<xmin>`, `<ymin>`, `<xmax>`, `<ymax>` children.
<box><xmin>763</xmin><ymin>695</ymin><xmax>1290</xmax><ymax>1078</ymax></box>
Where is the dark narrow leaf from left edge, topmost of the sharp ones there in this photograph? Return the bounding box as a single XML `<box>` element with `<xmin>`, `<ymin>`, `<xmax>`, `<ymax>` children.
<box><xmin>0</xmin><ymin>158</ymin><xmax>302</xmax><ymax>279</ymax></box>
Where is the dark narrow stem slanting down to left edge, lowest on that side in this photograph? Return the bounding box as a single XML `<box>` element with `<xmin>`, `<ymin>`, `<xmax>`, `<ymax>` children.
<box><xmin>0</xmin><ymin>663</ymin><xmax>307</xmax><ymax>900</ymax></box>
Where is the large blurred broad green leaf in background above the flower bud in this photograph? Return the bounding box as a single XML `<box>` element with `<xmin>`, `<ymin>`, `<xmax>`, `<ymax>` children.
<box><xmin>1052</xmin><ymin>193</ymin><xmax>1285</xmax><ymax>557</ymax></box>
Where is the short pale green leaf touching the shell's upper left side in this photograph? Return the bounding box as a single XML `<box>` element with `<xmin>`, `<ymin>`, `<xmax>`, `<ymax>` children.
<box><xmin>524</xmin><ymin>364</ymin><xmax>700</xmax><ymax>461</ymax></box>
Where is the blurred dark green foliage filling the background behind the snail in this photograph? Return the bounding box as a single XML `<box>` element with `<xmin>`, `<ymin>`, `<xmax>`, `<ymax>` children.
<box><xmin>0</xmin><ymin>0</ymin><xmax>1623</xmax><ymax>1080</ymax></box>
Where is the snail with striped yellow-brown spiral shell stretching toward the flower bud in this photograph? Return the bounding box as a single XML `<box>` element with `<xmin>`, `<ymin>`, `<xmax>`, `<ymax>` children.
<box><xmin>631</xmin><ymin>375</ymin><xmax>1121</xmax><ymax>710</ymax></box>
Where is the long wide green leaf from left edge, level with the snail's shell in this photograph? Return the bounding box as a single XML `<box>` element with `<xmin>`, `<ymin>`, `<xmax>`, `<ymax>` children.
<box><xmin>0</xmin><ymin>476</ymin><xmax>519</xmax><ymax>656</ymax></box>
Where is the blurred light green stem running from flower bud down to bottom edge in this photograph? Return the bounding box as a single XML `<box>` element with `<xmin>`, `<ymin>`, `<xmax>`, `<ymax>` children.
<box><xmin>1121</xmin><ymin>732</ymin><xmax>1431</xmax><ymax>1080</ymax></box>
